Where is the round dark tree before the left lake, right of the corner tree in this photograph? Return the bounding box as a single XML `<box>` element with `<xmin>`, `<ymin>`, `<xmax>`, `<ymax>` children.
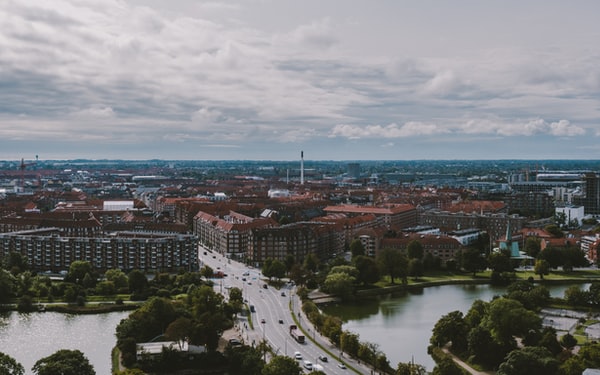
<box><xmin>32</xmin><ymin>349</ymin><xmax>96</xmax><ymax>375</ymax></box>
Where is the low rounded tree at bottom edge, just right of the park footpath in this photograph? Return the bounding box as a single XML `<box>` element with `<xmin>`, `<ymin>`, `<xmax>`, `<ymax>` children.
<box><xmin>496</xmin><ymin>346</ymin><xmax>559</xmax><ymax>375</ymax></box>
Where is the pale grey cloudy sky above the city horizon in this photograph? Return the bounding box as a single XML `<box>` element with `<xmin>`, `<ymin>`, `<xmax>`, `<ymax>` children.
<box><xmin>0</xmin><ymin>0</ymin><xmax>600</xmax><ymax>160</ymax></box>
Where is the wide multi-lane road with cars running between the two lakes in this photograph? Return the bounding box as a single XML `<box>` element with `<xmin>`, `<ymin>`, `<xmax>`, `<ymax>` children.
<box><xmin>199</xmin><ymin>248</ymin><xmax>371</xmax><ymax>375</ymax></box>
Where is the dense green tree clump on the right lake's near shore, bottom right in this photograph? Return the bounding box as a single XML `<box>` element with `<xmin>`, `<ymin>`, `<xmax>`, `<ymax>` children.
<box><xmin>429</xmin><ymin>281</ymin><xmax>600</xmax><ymax>375</ymax></box>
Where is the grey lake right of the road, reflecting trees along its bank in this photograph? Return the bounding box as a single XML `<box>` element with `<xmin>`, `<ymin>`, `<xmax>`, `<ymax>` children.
<box><xmin>322</xmin><ymin>284</ymin><xmax>589</xmax><ymax>371</ymax></box>
